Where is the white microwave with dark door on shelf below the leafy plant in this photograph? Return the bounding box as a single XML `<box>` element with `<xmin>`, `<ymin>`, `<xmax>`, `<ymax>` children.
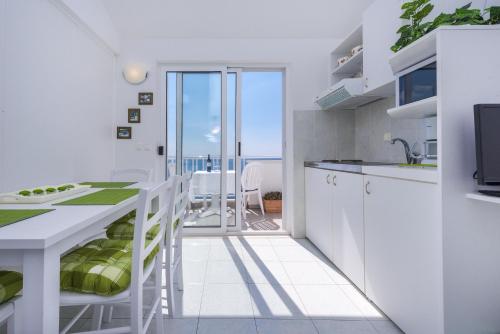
<box><xmin>396</xmin><ymin>57</ymin><xmax>437</xmax><ymax>107</ymax></box>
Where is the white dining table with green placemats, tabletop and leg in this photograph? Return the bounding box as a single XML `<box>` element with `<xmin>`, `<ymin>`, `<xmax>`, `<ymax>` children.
<box><xmin>0</xmin><ymin>182</ymin><xmax>154</xmax><ymax>334</ymax></box>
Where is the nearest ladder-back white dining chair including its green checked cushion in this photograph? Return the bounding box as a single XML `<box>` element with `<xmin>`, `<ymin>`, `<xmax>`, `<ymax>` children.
<box><xmin>60</xmin><ymin>177</ymin><xmax>179</xmax><ymax>334</ymax></box>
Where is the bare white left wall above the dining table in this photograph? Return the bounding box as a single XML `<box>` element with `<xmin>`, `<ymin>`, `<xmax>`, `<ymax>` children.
<box><xmin>0</xmin><ymin>0</ymin><xmax>116</xmax><ymax>191</ymax></box>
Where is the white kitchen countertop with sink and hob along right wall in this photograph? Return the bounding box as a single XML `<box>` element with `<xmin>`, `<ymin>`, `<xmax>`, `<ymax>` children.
<box><xmin>304</xmin><ymin>160</ymin><xmax>439</xmax><ymax>183</ymax></box>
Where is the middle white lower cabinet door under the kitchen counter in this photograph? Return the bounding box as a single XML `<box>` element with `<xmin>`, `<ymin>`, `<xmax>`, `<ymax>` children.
<box><xmin>332</xmin><ymin>172</ymin><xmax>365</xmax><ymax>291</ymax></box>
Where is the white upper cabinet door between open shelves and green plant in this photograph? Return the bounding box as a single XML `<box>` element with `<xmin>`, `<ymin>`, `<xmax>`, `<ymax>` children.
<box><xmin>363</xmin><ymin>0</ymin><xmax>402</xmax><ymax>94</ymax></box>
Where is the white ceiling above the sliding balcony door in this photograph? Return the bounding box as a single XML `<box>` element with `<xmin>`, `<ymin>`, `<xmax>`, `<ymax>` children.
<box><xmin>102</xmin><ymin>0</ymin><xmax>373</xmax><ymax>38</ymax></box>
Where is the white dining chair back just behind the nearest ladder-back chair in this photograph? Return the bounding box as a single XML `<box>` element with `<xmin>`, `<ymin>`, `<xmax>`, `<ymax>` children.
<box><xmin>164</xmin><ymin>173</ymin><xmax>192</xmax><ymax>318</ymax></box>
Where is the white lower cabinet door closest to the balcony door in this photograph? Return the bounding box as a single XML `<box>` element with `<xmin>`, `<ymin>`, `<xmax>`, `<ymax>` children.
<box><xmin>305</xmin><ymin>168</ymin><xmax>333</xmax><ymax>259</ymax></box>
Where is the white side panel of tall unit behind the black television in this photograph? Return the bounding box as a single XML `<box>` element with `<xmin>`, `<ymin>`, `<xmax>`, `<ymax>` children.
<box><xmin>440</xmin><ymin>29</ymin><xmax>500</xmax><ymax>334</ymax></box>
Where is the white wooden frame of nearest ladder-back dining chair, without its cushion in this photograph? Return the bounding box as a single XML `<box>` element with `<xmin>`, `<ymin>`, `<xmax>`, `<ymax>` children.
<box><xmin>60</xmin><ymin>177</ymin><xmax>179</xmax><ymax>334</ymax></box>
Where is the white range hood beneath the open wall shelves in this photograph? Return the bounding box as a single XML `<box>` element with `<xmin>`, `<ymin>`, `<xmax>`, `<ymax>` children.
<box><xmin>314</xmin><ymin>78</ymin><xmax>380</xmax><ymax>110</ymax></box>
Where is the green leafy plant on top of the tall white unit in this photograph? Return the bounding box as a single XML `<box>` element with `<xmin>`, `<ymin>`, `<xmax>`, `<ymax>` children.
<box><xmin>391</xmin><ymin>0</ymin><xmax>500</xmax><ymax>52</ymax></box>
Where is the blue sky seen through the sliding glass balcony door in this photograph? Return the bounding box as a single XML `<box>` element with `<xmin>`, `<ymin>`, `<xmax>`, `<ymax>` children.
<box><xmin>167</xmin><ymin>72</ymin><xmax>283</xmax><ymax>157</ymax></box>
